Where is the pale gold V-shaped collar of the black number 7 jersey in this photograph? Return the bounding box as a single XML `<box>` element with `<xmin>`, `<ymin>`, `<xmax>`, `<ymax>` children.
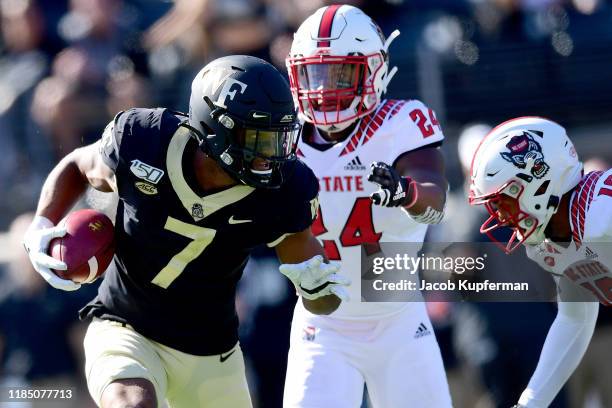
<box><xmin>166</xmin><ymin>127</ymin><xmax>255</xmax><ymax>221</ymax></box>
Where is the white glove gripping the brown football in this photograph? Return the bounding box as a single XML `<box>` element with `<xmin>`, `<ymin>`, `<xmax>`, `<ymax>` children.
<box><xmin>23</xmin><ymin>216</ymin><xmax>81</xmax><ymax>291</ymax></box>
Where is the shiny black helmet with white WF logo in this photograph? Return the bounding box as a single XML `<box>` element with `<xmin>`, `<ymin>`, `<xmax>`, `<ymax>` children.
<box><xmin>189</xmin><ymin>55</ymin><xmax>300</xmax><ymax>188</ymax></box>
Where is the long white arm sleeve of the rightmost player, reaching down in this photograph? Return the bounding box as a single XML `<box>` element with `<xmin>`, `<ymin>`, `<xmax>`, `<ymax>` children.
<box><xmin>519</xmin><ymin>302</ymin><xmax>599</xmax><ymax>408</ymax></box>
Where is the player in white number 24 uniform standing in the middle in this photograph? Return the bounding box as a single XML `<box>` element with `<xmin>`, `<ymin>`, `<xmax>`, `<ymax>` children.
<box><xmin>284</xmin><ymin>5</ymin><xmax>451</xmax><ymax>408</ymax></box>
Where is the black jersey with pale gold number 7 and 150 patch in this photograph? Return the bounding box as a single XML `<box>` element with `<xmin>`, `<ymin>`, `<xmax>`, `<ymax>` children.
<box><xmin>81</xmin><ymin>109</ymin><xmax>318</xmax><ymax>355</ymax></box>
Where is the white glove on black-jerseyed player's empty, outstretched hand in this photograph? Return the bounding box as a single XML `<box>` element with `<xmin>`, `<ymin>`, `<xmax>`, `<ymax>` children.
<box><xmin>279</xmin><ymin>255</ymin><xmax>351</xmax><ymax>301</ymax></box>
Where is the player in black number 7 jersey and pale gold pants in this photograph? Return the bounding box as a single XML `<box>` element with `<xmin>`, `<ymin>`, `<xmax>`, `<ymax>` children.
<box><xmin>24</xmin><ymin>56</ymin><xmax>348</xmax><ymax>408</ymax></box>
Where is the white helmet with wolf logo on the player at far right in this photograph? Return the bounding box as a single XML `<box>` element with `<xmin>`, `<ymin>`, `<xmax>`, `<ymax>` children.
<box><xmin>469</xmin><ymin>117</ymin><xmax>582</xmax><ymax>253</ymax></box>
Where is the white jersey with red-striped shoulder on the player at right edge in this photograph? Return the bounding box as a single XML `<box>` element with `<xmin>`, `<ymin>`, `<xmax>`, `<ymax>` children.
<box><xmin>527</xmin><ymin>169</ymin><xmax>612</xmax><ymax>305</ymax></box>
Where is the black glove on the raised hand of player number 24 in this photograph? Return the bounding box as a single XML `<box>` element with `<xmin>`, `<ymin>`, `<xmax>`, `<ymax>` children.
<box><xmin>368</xmin><ymin>162</ymin><xmax>417</xmax><ymax>208</ymax></box>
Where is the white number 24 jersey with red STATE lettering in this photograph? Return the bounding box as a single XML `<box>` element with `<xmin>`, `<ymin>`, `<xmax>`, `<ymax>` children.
<box><xmin>298</xmin><ymin>100</ymin><xmax>444</xmax><ymax>318</ymax></box>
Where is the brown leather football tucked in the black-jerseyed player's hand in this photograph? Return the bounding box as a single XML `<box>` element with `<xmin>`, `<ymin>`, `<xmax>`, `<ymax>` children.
<box><xmin>49</xmin><ymin>209</ymin><xmax>115</xmax><ymax>283</ymax></box>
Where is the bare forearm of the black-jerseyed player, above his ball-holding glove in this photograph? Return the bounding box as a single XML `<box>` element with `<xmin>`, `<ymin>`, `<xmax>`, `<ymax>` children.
<box><xmin>36</xmin><ymin>152</ymin><xmax>89</xmax><ymax>224</ymax></box>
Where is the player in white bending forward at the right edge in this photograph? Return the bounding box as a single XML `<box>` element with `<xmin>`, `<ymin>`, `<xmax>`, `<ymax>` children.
<box><xmin>470</xmin><ymin>117</ymin><xmax>612</xmax><ymax>408</ymax></box>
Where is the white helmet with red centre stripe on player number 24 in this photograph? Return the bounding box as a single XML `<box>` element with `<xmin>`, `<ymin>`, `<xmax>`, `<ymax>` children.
<box><xmin>286</xmin><ymin>4</ymin><xmax>399</xmax><ymax>132</ymax></box>
